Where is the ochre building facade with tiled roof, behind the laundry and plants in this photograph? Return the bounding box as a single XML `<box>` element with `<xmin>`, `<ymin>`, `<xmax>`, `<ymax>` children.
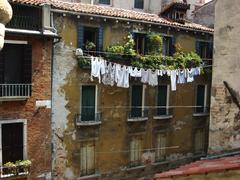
<box><xmin>47</xmin><ymin>2</ymin><xmax>212</xmax><ymax>179</ymax></box>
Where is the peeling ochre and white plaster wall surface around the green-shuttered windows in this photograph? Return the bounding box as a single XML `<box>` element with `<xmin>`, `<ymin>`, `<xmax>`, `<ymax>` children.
<box><xmin>53</xmin><ymin>16</ymin><xmax>209</xmax><ymax>179</ymax></box>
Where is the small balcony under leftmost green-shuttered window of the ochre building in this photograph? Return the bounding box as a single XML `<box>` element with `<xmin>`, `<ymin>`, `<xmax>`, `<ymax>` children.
<box><xmin>75</xmin><ymin>112</ymin><xmax>102</xmax><ymax>126</ymax></box>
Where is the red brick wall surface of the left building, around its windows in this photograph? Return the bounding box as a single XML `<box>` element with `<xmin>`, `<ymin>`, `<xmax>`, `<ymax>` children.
<box><xmin>0</xmin><ymin>35</ymin><xmax>52</xmax><ymax>179</ymax></box>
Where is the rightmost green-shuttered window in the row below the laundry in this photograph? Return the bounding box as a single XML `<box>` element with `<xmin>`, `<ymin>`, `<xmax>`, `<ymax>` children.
<box><xmin>196</xmin><ymin>85</ymin><xmax>207</xmax><ymax>113</ymax></box>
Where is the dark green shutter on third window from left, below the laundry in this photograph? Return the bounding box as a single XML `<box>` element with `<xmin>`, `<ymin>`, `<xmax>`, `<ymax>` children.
<box><xmin>157</xmin><ymin>85</ymin><xmax>167</xmax><ymax>116</ymax></box>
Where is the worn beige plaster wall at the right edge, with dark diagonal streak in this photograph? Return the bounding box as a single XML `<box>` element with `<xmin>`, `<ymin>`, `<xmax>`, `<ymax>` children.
<box><xmin>209</xmin><ymin>0</ymin><xmax>240</xmax><ymax>153</ymax></box>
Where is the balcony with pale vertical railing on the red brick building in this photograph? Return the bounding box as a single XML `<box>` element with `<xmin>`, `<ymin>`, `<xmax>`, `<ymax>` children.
<box><xmin>0</xmin><ymin>84</ymin><xmax>32</xmax><ymax>101</ymax></box>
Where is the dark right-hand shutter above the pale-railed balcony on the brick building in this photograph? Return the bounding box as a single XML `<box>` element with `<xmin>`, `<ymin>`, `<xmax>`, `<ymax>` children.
<box><xmin>23</xmin><ymin>44</ymin><xmax>32</xmax><ymax>84</ymax></box>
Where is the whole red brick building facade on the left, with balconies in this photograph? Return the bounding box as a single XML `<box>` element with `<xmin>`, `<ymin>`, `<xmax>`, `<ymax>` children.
<box><xmin>0</xmin><ymin>1</ymin><xmax>56</xmax><ymax>179</ymax></box>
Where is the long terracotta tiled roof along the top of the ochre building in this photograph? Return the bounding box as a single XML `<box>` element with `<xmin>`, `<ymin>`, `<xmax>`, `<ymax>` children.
<box><xmin>10</xmin><ymin>0</ymin><xmax>214</xmax><ymax>33</ymax></box>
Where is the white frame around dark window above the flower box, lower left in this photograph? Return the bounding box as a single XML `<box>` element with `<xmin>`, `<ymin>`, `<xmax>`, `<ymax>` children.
<box><xmin>0</xmin><ymin>119</ymin><xmax>27</xmax><ymax>166</ymax></box>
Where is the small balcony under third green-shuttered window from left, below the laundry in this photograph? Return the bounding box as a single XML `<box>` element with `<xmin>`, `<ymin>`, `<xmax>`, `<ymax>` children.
<box><xmin>153</xmin><ymin>106</ymin><xmax>173</xmax><ymax>120</ymax></box>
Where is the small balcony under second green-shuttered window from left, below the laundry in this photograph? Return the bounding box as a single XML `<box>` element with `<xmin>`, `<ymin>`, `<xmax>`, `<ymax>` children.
<box><xmin>128</xmin><ymin>108</ymin><xmax>148</xmax><ymax>122</ymax></box>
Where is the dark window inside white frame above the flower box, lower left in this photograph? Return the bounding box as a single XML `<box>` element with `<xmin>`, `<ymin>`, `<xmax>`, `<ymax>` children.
<box><xmin>1</xmin><ymin>123</ymin><xmax>24</xmax><ymax>165</ymax></box>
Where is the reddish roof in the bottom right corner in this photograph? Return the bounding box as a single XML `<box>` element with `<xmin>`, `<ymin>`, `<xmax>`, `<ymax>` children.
<box><xmin>154</xmin><ymin>155</ymin><xmax>240</xmax><ymax>180</ymax></box>
